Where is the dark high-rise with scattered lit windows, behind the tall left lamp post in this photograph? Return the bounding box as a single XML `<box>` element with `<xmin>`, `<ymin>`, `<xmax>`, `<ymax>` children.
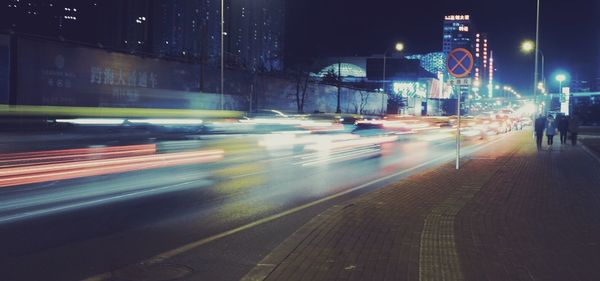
<box><xmin>153</xmin><ymin>0</ymin><xmax>284</xmax><ymax>71</ymax></box>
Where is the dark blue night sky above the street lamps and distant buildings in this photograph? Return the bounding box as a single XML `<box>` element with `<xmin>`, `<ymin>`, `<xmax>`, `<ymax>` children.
<box><xmin>286</xmin><ymin>0</ymin><xmax>600</xmax><ymax>94</ymax></box>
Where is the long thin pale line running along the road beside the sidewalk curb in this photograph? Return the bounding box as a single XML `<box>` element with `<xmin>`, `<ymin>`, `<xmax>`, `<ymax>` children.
<box><xmin>82</xmin><ymin>133</ymin><xmax>504</xmax><ymax>281</ymax></box>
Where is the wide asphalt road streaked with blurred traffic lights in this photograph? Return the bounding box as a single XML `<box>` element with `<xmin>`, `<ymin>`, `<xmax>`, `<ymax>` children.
<box><xmin>0</xmin><ymin>127</ymin><xmax>508</xmax><ymax>281</ymax></box>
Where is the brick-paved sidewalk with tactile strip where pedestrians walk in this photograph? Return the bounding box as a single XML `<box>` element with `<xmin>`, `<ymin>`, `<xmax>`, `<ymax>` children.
<box><xmin>244</xmin><ymin>132</ymin><xmax>600</xmax><ymax>280</ymax></box>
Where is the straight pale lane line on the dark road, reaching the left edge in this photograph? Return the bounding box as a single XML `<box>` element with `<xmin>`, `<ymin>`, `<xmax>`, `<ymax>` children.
<box><xmin>0</xmin><ymin>179</ymin><xmax>206</xmax><ymax>224</ymax></box>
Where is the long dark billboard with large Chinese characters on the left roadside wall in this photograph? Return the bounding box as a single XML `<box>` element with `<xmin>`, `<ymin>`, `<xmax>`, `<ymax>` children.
<box><xmin>16</xmin><ymin>38</ymin><xmax>200</xmax><ymax>108</ymax></box>
